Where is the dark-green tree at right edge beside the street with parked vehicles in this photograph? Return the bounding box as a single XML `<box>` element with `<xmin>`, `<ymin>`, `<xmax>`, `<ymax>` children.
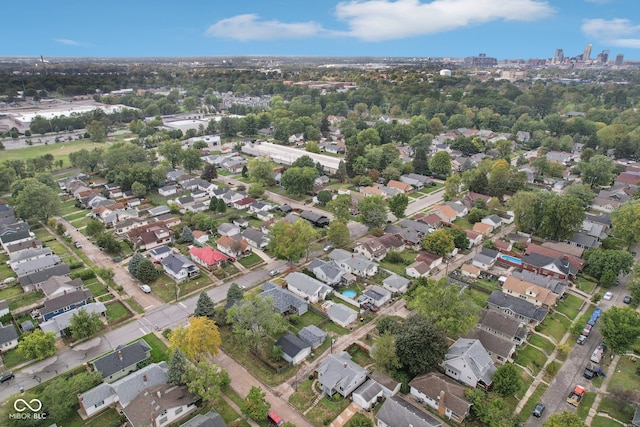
<box><xmin>600</xmin><ymin>307</ymin><xmax>640</xmax><ymax>354</ymax></box>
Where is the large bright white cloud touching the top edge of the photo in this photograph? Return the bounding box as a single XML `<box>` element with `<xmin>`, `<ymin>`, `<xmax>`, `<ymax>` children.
<box><xmin>336</xmin><ymin>0</ymin><xmax>554</xmax><ymax>41</ymax></box>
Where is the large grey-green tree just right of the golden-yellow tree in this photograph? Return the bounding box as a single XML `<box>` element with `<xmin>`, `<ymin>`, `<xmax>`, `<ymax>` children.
<box><xmin>227</xmin><ymin>296</ymin><xmax>288</xmax><ymax>350</ymax></box>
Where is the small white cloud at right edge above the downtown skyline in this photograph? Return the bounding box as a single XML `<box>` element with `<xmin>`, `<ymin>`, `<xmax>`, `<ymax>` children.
<box><xmin>582</xmin><ymin>18</ymin><xmax>640</xmax><ymax>49</ymax></box>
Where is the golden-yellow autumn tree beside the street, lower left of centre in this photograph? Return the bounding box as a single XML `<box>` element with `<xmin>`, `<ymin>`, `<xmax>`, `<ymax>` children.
<box><xmin>169</xmin><ymin>316</ymin><xmax>221</xmax><ymax>361</ymax></box>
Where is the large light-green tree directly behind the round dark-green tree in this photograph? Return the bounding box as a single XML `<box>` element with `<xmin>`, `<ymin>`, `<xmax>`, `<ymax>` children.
<box><xmin>407</xmin><ymin>277</ymin><xmax>480</xmax><ymax>336</ymax></box>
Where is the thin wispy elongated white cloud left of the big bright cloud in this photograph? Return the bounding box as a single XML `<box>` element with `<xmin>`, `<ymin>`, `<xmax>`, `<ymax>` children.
<box><xmin>205</xmin><ymin>14</ymin><xmax>324</xmax><ymax>41</ymax></box>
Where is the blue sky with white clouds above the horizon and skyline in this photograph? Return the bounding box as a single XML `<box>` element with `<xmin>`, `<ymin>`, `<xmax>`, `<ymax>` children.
<box><xmin>0</xmin><ymin>0</ymin><xmax>640</xmax><ymax>59</ymax></box>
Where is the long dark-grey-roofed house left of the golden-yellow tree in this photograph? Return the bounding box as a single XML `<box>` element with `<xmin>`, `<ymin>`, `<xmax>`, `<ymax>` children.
<box><xmin>91</xmin><ymin>339</ymin><xmax>151</xmax><ymax>383</ymax></box>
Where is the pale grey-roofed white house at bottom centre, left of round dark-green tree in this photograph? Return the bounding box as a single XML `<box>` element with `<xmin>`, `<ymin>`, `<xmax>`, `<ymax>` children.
<box><xmin>316</xmin><ymin>351</ymin><xmax>367</xmax><ymax>397</ymax></box>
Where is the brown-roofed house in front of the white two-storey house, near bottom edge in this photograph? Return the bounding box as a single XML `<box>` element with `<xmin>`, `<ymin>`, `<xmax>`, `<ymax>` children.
<box><xmin>409</xmin><ymin>372</ymin><xmax>471</xmax><ymax>423</ymax></box>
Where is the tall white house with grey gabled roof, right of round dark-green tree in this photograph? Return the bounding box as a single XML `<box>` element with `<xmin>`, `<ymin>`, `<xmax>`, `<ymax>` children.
<box><xmin>442</xmin><ymin>338</ymin><xmax>496</xmax><ymax>389</ymax></box>
